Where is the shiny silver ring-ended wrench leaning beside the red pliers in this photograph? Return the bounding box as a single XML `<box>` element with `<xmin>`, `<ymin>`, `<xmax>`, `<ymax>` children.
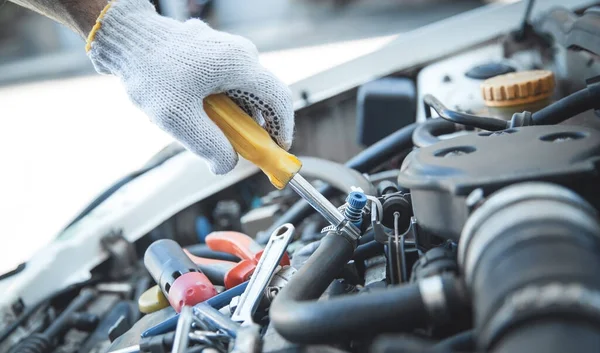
<box><xmin>231</xmin><ymin>223</ymin><xmax>294</xmax><ymax>326</ymax></box>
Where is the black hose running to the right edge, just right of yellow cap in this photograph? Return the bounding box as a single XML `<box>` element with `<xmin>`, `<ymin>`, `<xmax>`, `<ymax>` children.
<box><xmin>531</xmin><ymin>86</ymin><xmax>600</xmax><ymax>125</ymax></box>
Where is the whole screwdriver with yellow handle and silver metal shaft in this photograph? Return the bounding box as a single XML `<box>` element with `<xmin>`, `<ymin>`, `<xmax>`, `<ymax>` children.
<box><xmin>204</xmin><ymin>93</ymin><xmax>360</xmax><ymax>239</ymax></box>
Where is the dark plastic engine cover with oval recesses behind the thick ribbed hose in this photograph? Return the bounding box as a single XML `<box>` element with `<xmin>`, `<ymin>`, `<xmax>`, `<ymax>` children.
<box><xmin>398</xmin><ymin>125</ymin><xmax>600</xmax><ymax>240</ymax></box>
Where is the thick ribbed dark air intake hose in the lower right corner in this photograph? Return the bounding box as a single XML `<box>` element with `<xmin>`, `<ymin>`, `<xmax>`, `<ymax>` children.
<box><xmin>459</xmin><ymin>182</ymin><xmax>600</xmax><ymax>353</ymax></box>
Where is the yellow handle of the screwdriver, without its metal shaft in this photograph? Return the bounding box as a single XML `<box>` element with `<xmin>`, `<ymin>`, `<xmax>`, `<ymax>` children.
<box><xmin>204</xmin><ymin>94</ymin><xmax>302</xmax><ymax>189</ymax></box>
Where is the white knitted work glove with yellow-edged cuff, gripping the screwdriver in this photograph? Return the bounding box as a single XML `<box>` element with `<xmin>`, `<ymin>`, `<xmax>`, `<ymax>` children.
<box><xmin>86</xmin><ymin>0</ymin><xmax>294</xmax><ymax>174</ymax></box>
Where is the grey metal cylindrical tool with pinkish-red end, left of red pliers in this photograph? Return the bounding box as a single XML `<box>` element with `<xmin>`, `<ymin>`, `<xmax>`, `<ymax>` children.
<box><xmin>144</xmin><ymin>239</ymin><xmax>217</xmax><ymax>311</ymax></box>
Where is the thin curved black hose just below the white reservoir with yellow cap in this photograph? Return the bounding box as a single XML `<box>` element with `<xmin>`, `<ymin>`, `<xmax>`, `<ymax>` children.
<box><xmin>423</xmin><ymin>94</ymin><xmax>510</xmax><ymax>131</ymax></box>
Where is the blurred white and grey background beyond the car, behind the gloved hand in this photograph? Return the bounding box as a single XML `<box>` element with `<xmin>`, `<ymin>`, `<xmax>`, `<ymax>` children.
<box><xmin>0</xmin><ymin>0</ymin><xmax>490</xmax><ymax>273</ymax></box>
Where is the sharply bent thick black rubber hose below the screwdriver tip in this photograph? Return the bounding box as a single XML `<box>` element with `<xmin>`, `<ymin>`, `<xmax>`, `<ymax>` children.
<box><xmin>269</xmin><ymin>233</ymin><xmax>428</xmax><ymax>344</ymax></box>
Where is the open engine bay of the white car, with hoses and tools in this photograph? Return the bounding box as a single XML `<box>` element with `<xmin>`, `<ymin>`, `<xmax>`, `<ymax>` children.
<box><xmin>0</xmin><ymin>2</ymin><xmax>600</xmax><ymax>353</ymax></box>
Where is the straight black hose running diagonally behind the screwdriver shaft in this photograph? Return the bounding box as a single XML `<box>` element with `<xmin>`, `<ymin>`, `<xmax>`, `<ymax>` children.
<box><xmin>256</xmin><ymin>123</ymin><xmax>418</xmax><ymax>244</ymax></box>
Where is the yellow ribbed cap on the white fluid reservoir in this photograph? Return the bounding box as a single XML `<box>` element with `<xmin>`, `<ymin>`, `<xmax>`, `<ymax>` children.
<box><xmin>481</xmin><ymin>70</ymin><xmax>554</xmax><ymax>107</ymax></box>
